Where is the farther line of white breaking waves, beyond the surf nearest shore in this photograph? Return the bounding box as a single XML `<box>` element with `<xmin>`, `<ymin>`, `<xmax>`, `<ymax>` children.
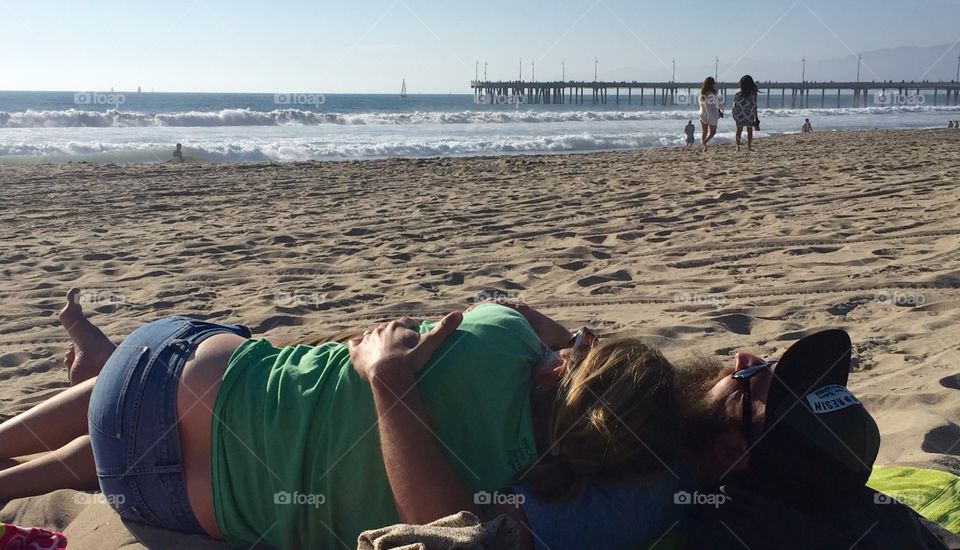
<box><xmin>0</xmin><ymin>105</ymin><xmax>960</xmax><ymax>128</ymax></box>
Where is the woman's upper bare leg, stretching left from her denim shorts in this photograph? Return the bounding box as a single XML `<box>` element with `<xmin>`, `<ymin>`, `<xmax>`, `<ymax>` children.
<box><xmin>0</xmin><ymin>378</ymin><xmax>97</xmax><ymax>462</ymax></box>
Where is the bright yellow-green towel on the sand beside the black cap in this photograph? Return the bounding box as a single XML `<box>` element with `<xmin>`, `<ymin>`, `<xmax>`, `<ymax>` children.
<box><xmin>867</xmin><ymin>466</ymin><xmax>960</xmax><ymax>535</ymax></box>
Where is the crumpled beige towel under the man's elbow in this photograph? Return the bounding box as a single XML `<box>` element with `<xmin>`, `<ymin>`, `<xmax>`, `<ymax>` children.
<box><xmin>357</xmin><ymin>512</ymin><xmax>520</xmax><ymax>550</ymax></box>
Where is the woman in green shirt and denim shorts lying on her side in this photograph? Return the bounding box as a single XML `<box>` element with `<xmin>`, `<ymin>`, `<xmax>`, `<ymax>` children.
<box><xmin>0</xmin><ymin>290</ymin><xmax>724</xmax><ymax>550</ymax></box>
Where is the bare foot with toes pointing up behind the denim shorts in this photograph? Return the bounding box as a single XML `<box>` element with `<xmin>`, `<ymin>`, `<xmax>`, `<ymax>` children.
<box><xmin>59</xmin><ymin>288</ymin><xmax>117</xmax><ymax>386</ymax></box>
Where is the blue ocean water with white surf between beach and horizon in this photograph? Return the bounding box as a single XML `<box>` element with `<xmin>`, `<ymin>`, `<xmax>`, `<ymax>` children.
<box><xmin>0</xmin><ymin>91</ymin><xmax>960</xmax><ymax>163</ymax></box>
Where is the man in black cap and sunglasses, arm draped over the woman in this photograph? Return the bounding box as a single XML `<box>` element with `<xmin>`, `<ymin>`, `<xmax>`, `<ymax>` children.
<box><xmin>336</xmin><ymin>316</ymin><xmax>960</xmax><ymax>549</ymax></box>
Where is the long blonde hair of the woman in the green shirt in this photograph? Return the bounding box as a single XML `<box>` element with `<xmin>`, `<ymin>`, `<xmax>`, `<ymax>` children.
<box><xmin>523</xmin><ymin>339</ymin><xmax>679</xmax><ymax>500</ymax></box>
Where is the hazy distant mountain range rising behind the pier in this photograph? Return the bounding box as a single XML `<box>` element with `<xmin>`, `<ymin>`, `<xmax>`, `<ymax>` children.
<box><xmin>601</xmin><ymin>44</ymin><xmax>960</xmax><ymax>82</ymax></box>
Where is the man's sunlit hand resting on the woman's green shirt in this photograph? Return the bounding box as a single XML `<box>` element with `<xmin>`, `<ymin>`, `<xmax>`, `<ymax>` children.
<box><xmin>348</xmin><ymin>311</ymin><xmax>463</xmax><ymax>382</ymax></box>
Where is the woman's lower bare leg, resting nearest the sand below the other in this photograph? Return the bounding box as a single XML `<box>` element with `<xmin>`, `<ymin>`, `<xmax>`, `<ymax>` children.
<box><xmin>0</xmin><ymin>435</ymin><xmax>99</xmax><ymax>502</ymax></box>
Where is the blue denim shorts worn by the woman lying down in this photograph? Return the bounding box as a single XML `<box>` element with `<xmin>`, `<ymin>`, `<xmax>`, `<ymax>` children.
<box><xmin>88</xmin><ymin>317</ymin><xmax>251</xmax><ymax>534</ymax></box>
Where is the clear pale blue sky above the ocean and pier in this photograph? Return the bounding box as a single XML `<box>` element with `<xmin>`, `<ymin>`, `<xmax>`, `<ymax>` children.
<box><xmin>0</xmin><ymin>0</ymin><xmax>960</xmax><ymax>93</ymax></box>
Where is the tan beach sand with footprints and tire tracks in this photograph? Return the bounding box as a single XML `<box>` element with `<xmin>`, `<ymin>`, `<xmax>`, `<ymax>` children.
<box><xmin>0</xmin><ymin>130</ymin><xmax>960</xmax><ymax>548</ymax></box>
